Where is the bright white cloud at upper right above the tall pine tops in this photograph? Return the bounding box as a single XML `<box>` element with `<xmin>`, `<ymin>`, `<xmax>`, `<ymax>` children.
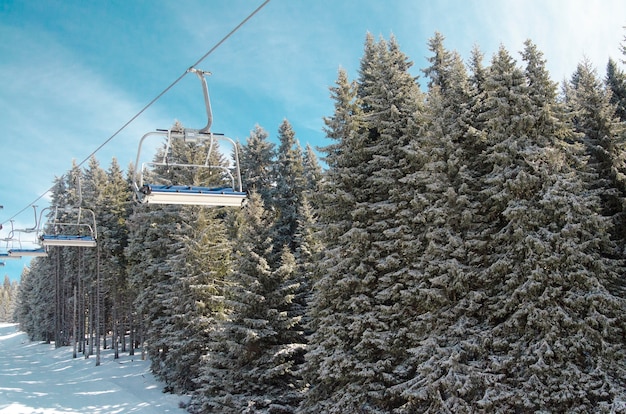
<box><xmin>430</xmin><ymin>0</ymin><xmax>626</xmax><ymax>81</ymax></box>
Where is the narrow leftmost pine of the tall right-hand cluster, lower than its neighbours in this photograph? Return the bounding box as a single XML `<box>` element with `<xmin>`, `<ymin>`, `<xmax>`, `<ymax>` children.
<box><xmin>301</xmin><ymin>68</ymin><xmax>362</xmax><ymax>412</ymax></box>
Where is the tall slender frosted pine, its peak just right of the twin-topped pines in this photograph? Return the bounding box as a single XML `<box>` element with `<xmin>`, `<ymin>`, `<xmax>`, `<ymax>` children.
<box><xmin>395</xmin><ymin>34</ymin><xmax>488</xmax><ymax>412</ymax></box>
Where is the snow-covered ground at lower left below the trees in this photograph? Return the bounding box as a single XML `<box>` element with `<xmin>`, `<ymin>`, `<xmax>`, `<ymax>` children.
<box><xmin>0</xmin><ymin>324</ymin><xmax>186</xmax><ymax>414</ymax></box>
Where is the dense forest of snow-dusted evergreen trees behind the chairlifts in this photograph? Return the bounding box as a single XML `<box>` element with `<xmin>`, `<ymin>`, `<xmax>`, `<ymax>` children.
<box><xmin>17</xmin><ymin>33</ymin><xmax>626</xmax><ymax>413</ymax></box>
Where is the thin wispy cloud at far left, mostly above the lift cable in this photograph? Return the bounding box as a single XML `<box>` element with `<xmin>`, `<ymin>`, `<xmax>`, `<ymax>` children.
<box><xmin>0</xmin><ymin>26</ymin><xmax>163</xmax><ymax>220</ymax></box>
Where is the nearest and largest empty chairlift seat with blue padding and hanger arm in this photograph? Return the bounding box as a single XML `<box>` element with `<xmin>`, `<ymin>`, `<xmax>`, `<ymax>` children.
<box><xmin>133</xmin><ymin>68</ymin><xmax>246</xmax><ymax>207</ymax></box>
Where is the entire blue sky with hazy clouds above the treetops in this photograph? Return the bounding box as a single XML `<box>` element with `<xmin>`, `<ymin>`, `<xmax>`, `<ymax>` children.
<box><xmin>0</xmin><ymin>0</ymin><xmax>626</xmax><ymax>280</ymax></box>
